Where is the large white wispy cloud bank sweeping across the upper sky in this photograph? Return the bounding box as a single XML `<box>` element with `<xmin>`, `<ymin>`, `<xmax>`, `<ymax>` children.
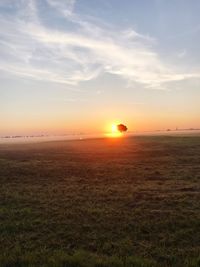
<box><xmin>0</xmin><ymin>0</ymin><xmax>200</xmax><ymax>88</ymax></box>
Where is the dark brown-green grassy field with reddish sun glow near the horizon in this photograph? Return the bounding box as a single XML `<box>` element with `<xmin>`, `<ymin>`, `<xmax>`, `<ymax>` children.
<box><xmin>0</xmin><ymin>136</ymin><xmax>200</xmax><ymax>267</ymax></box>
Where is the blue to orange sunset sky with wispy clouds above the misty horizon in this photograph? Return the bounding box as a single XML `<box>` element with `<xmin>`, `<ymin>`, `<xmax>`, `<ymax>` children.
<box><xmin>0</xmin><ymin>0</ymin><xmax>200</xmax><ymax>135</ymax></box>
